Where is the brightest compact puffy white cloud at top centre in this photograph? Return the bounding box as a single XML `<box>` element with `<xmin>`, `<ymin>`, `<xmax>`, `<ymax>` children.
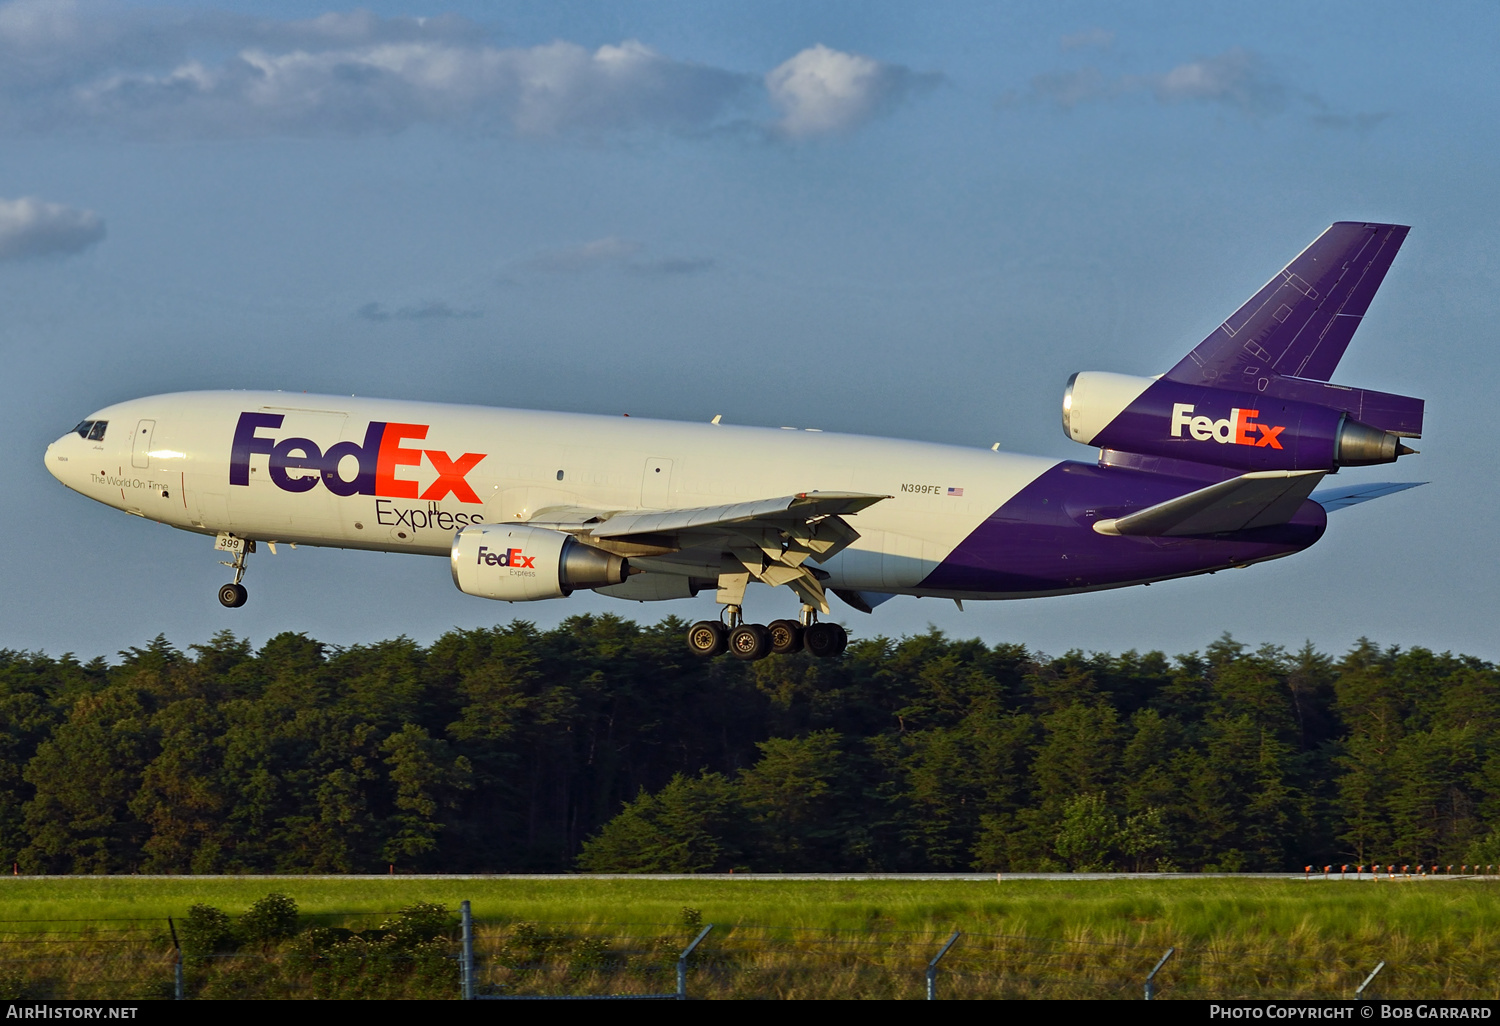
<box><xmin>765</xmin><ymin>44</ymin><xmax>936</xmax><ymax>138</ymax></box>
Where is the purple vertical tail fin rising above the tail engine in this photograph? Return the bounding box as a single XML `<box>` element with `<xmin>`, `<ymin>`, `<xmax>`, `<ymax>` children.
<box><xmin>1166</xmin><ymin>221</ymin><xmax>1410</xmax><ymax>393</ymax></box>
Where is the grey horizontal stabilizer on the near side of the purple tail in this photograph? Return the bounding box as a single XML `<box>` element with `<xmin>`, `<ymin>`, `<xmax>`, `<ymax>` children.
<box><xmin>1094</xmin><ymin>471</ymin><xmax>1323</xmax><ymax>539</ymax></box>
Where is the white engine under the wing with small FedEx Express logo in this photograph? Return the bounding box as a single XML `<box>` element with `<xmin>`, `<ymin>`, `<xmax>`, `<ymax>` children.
<box><xmin>449</xmin><ymin>524</ymin><xmax>630</xmax><ymax>602</ymax></box>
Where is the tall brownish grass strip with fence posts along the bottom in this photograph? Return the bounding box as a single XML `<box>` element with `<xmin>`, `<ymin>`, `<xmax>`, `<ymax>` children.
<box><xmin>0</xmin><ymin>902</ymin><xmax>1500</xmax><ymax>1001</ymax></box>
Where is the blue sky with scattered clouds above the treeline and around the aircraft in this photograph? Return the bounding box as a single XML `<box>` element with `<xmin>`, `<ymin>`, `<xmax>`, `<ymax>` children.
<box><xmin>0</xmin><ymin>2</ymin><xmax>1500</xmax><ymax>659</ymax></box>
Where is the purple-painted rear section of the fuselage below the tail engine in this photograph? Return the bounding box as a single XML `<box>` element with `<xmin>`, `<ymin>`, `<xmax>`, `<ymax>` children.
<box><xmin>921</xmin><ymin>462</ymin><xmax>1328</xmax><ymax>594</ymax></box>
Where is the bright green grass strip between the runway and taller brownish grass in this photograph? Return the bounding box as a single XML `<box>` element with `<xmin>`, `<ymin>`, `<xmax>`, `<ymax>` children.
<box><xmin>0</xmin><ymin>876</ymin><xmax>1500</xmax><ymax>951</ymax></box>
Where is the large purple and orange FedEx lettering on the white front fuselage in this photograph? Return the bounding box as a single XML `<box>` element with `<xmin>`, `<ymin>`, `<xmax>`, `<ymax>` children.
<box><xmin>230</xmin><ymin>413</ymin><xmax>486</xmax><ymax>503</ymax></box>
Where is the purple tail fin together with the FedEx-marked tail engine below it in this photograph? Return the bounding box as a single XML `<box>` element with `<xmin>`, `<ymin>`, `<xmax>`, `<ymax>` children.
<box><xmin>1062</xmin><ymin>221</ymin><xmax>1425</xmax><ymax>480</ymax></box>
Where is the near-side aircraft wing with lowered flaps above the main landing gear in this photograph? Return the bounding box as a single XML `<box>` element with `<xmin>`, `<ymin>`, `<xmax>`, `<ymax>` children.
<box><xmin>530</xmin><ymin>492</ymin><xmax>890</xmax><ymax>612</ymax></box>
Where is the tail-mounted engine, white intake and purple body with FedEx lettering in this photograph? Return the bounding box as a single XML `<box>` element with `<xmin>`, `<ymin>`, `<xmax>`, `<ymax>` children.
<box><xmin>1062</xmin><ymin>371</ymin><xmax>1416</xmax><ymax>471</ymax></box>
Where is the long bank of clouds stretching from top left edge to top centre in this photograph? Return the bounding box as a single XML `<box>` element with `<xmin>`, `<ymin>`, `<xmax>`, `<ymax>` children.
<box><xmin>0</xmin><ymin>0</ymin><xmax>938</xmax><ymax>140</ymax></box>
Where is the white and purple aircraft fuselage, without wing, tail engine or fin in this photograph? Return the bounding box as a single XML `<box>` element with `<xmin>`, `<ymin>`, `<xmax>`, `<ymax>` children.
<box><xmin>47</xmin><ymin>392</ymin><xmax>1326</xmax><ymax>599</ymax></box>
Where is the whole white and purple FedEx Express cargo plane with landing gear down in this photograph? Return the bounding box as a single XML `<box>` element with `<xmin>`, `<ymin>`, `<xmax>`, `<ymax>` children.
<box><xmin>47</xmin><ymin>222</ymin><xmax>1424</xmax><ymax>660</ymax></box>
